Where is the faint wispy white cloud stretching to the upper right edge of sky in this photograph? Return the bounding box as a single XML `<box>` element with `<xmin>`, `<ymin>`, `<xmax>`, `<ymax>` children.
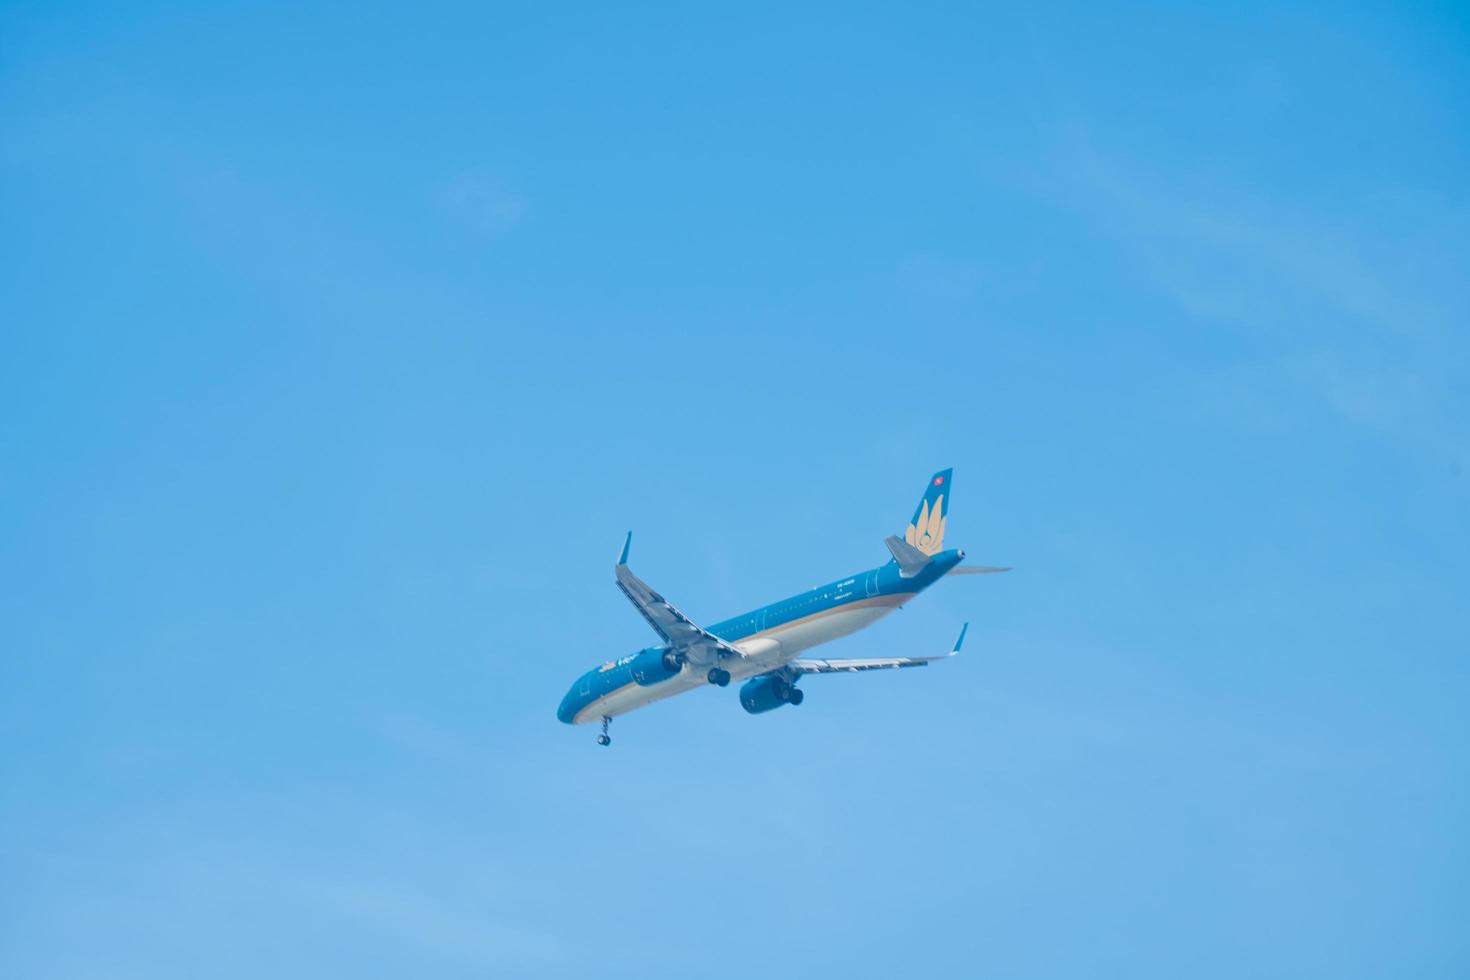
<box><xmin>1045</xmin><ymin>132</ymin><xmax>1470</xmax><ymax>466</ymax></box>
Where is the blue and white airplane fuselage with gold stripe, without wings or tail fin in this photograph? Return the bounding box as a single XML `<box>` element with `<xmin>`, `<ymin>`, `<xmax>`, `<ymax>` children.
<box><xmin>557</xmin><ymin>550</ymin><xmax>964</xmax><ymax>724</ymax></box>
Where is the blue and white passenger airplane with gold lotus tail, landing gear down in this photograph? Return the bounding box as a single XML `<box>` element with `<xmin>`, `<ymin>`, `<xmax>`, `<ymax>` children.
<box><xmin>556</xmin><ymin>469</ymin><xmax>1010</xmax><ymax>745</ymax></box>
